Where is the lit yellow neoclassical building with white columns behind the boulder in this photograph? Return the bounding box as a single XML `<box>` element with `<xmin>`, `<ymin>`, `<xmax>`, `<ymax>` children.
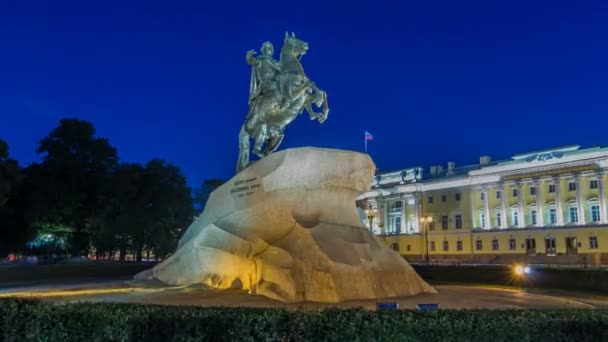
<box><xmin>357</xmin><ymin>145</ymin><xmax>608</xmax><ymax>265</ymax></box>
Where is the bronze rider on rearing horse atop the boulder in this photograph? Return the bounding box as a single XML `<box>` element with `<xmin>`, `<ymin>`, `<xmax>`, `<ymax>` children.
<box><xmin>236</xmin><ymin>33</ymin><xmax>329</xmax><ymax>172</ymax></box>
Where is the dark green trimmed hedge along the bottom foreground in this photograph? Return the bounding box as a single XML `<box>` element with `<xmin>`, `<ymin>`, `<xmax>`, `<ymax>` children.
<box><xmin>0</xmin><ymin>299</ymin><xmax>608</xmax><ymax>342</ymax></box>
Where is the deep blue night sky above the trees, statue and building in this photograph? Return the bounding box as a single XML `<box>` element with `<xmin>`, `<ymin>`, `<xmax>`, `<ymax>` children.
<box><xmin>0</xmin><ymin>0</ymin><xmax>608</xmax><ymax>185</ymax></box>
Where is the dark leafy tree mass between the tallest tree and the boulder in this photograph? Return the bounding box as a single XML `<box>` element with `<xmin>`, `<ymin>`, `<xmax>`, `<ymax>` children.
<box><xmin>93</xmin><ymin>159</ymin><xmax>194</xmax><ymax>261</ymax></box>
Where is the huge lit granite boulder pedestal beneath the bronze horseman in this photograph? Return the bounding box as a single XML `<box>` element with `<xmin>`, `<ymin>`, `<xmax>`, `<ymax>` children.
<box><xmin>136</xmin><ymin>148</ymin><xmax>435</xmax><ymax>302</ymax></box>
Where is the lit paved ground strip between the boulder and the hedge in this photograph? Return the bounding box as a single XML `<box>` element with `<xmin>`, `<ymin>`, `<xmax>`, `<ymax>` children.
<box><xmin>0</xmin><ymin>281</ymin><xmax>608</xmax><ymax>309</ymax></box>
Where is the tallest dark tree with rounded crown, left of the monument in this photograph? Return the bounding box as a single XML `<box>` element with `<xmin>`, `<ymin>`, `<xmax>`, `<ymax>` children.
<box><xmin>31</xmin><ymin>119</ymin><xmax>118</xmax><ymax>256</ymax></box>
